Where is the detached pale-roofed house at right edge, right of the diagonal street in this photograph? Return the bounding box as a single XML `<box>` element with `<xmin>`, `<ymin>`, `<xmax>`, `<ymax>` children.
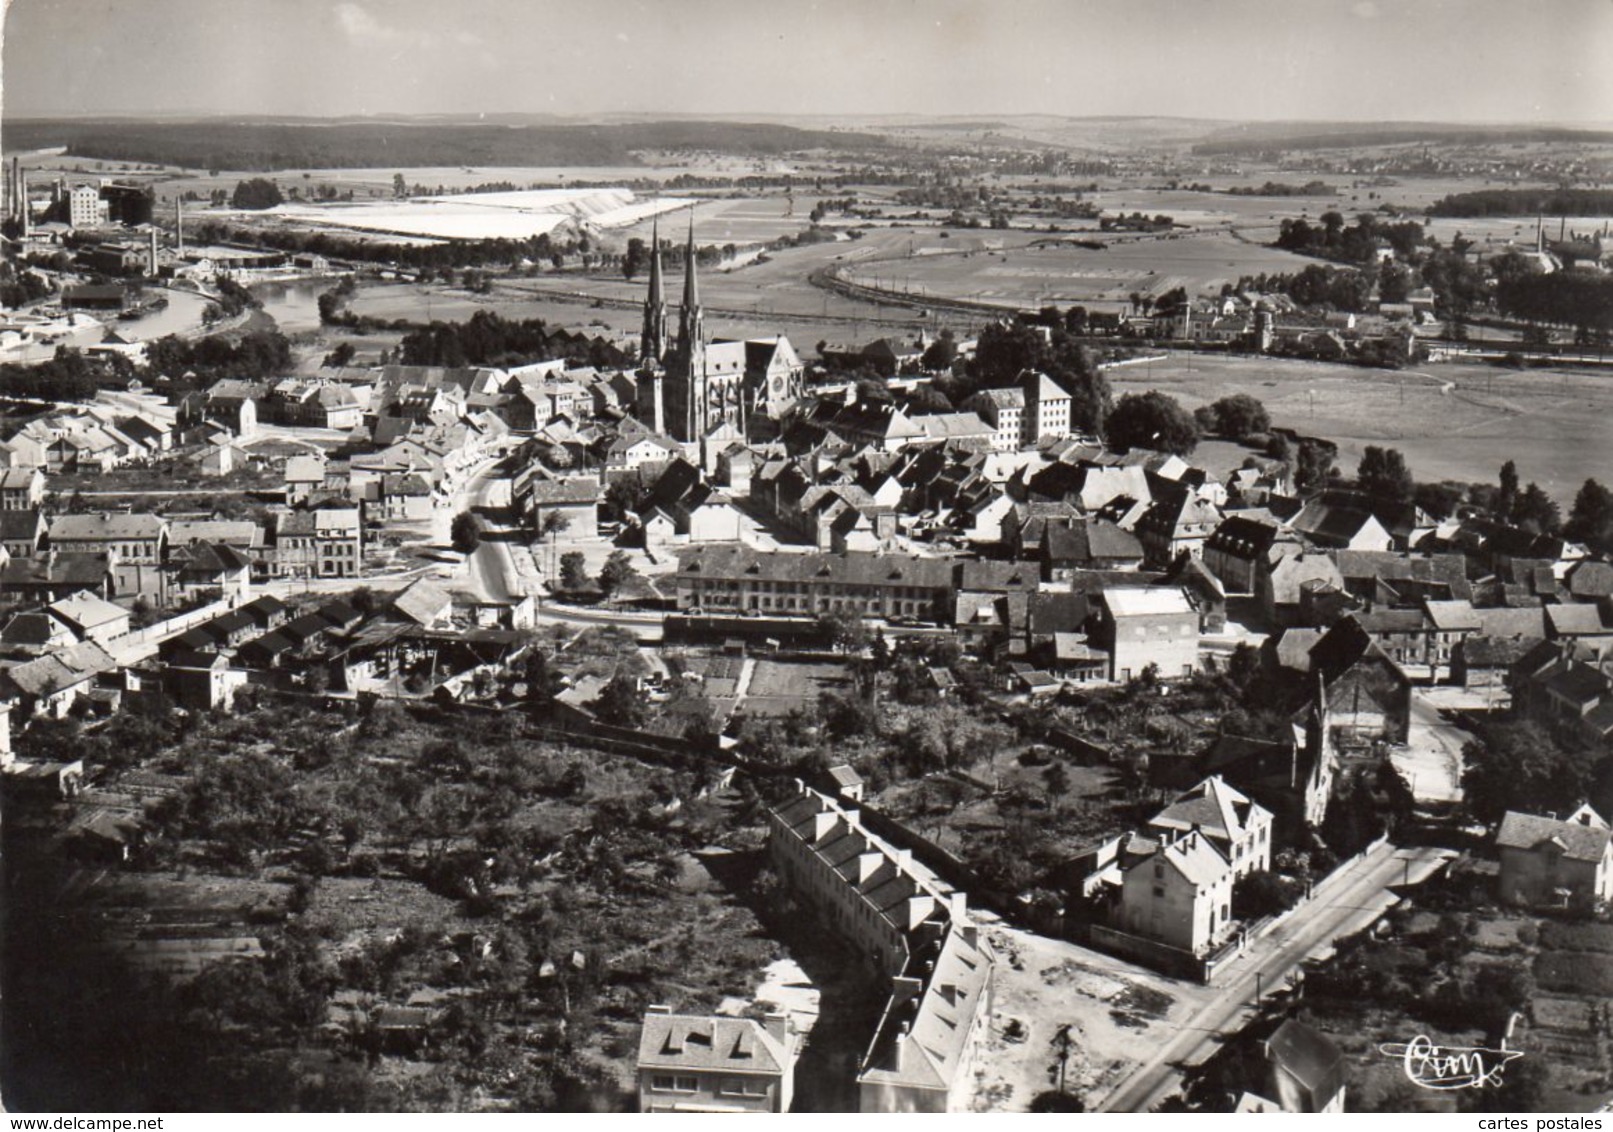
<box><xmin>1495</xmin><ymin>803</ymin><xmax>1613</xmax><ymax>908</ymax></box>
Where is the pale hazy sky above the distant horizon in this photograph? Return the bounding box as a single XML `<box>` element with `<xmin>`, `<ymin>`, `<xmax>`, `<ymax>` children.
<box><xmin>9</xmin><ymin>0</ymin><xmax>1613</xmax><ymax>124</ymax></box>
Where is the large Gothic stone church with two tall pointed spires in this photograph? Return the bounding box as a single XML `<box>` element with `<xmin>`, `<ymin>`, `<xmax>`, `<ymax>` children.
<box><xmin>639</xmin><ymin>216</ymin><xmax>805</xmax><ymax>456</ymax></box>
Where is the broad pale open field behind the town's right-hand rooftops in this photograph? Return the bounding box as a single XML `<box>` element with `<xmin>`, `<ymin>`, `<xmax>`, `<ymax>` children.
<box><xmin>1108</xmin><ymin>355</ymin><xmax>1613</xmax><ymax>506</ymax></box>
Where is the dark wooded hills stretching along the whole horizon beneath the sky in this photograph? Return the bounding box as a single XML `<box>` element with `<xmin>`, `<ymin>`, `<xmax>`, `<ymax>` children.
<box><xmin>5</xmin><ymin>113</ymin><xmax>1613</xmax><ymax>173</ymax></box>
